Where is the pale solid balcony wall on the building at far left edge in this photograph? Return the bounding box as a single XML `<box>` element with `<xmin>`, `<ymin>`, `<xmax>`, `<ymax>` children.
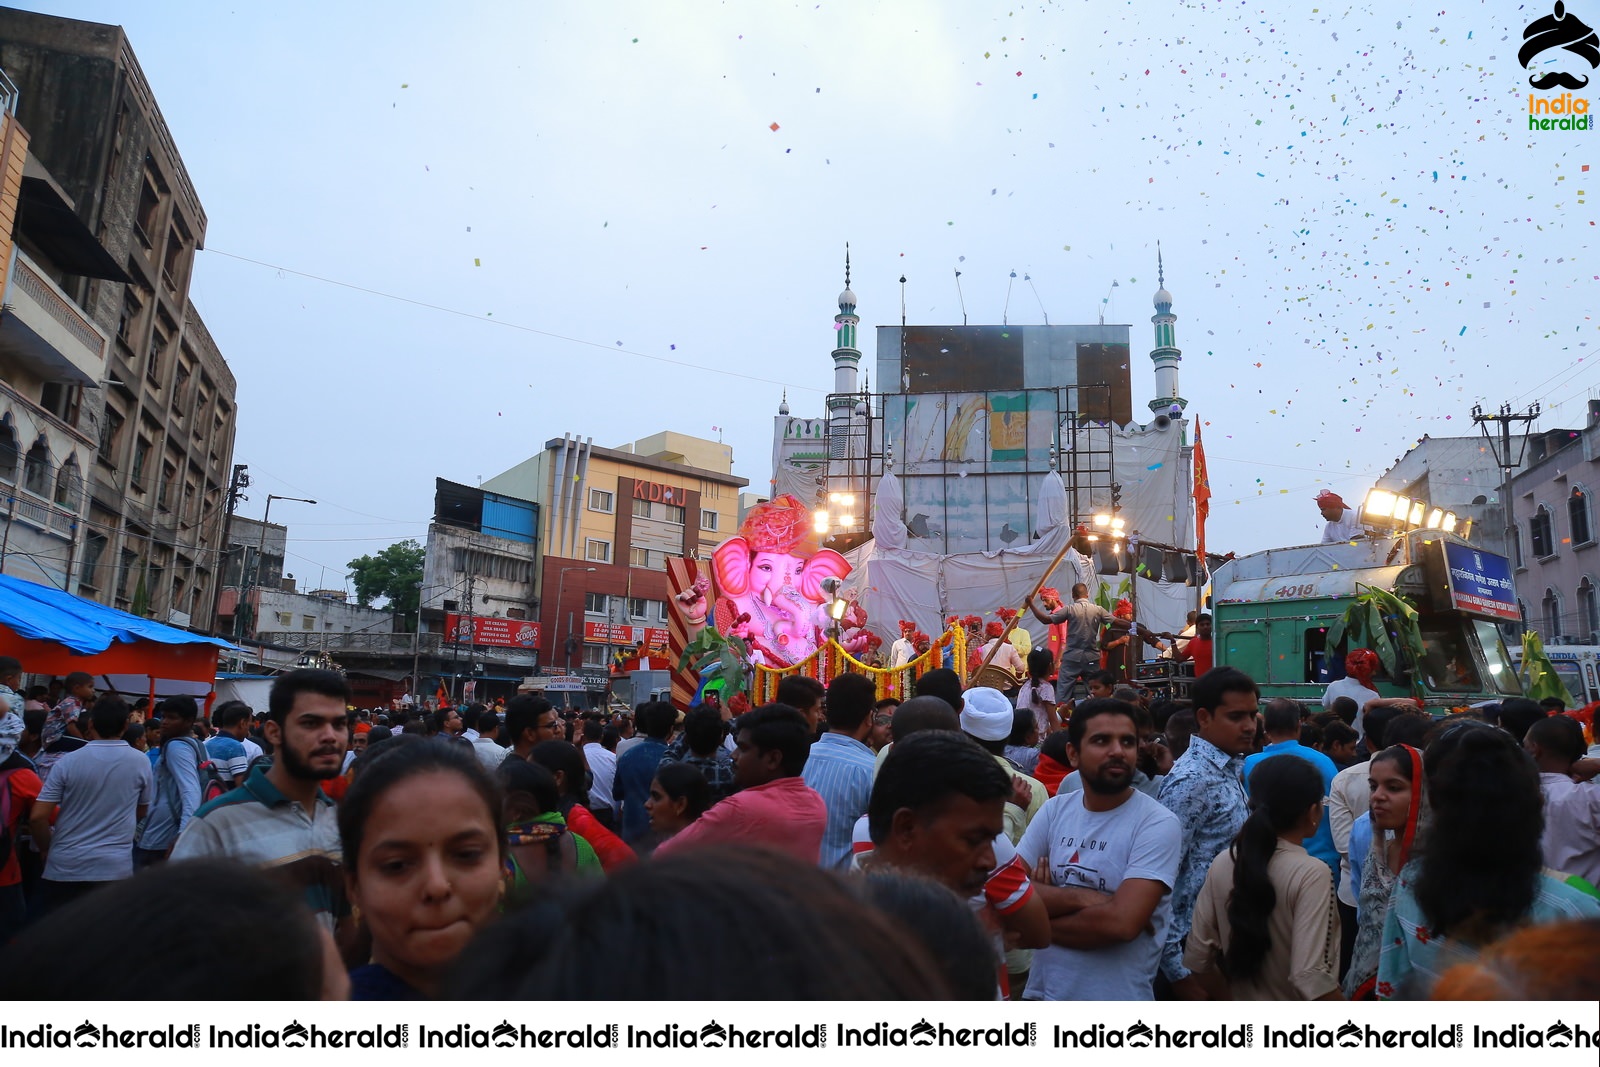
<box><xmin>0</xmin><ymin>248</ymin><xmax>106</xmax><ymax>389</ymax></box>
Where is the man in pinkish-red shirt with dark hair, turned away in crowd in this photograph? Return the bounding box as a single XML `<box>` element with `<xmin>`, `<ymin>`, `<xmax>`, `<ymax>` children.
<box><xmin>656</xmin><ymin>704</ymin><xmax>827</xmax><ymax>865</ymax></box>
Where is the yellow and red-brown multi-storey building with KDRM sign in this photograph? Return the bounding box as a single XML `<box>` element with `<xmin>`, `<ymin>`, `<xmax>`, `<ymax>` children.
<box><xmin>483</xmin><ymin>432</ymin><xmax>749</xmax><ymax>677</ymax></box>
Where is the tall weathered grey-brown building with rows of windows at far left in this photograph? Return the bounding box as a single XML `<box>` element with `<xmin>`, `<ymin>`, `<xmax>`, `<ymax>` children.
<box><xmin>0</xmin><ymin>8</ymin><xmax>237</xmax><ymax>629</ymax></box>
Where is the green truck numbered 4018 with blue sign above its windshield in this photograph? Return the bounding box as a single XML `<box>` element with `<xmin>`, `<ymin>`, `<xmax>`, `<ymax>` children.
<box><xmin>1211</xmin><ymin>530</ymin><xmax>1522</xmax><ymax>712</ymax></box>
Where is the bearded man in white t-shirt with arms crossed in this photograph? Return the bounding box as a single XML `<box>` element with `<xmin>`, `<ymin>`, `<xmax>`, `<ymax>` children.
<box><xmin>1016</xmin><ymin>701</ymin><xmax>1182</xmax><ymax>1000</ymax></box>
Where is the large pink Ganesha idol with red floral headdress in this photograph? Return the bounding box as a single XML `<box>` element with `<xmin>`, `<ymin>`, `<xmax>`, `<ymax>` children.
<box><xmin>710</xmin><ymin>493</ymin><xmax>869</xmax><ymax>665</ymax></box>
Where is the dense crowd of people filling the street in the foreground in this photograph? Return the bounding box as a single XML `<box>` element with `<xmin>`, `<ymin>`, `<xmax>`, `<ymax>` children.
<box><xmin>0</xmin><ymin>649</ymin><xmax>1600</xmax><ymax>1000</ymax></box>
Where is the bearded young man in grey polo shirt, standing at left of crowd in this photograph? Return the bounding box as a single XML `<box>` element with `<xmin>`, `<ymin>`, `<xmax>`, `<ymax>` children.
<box><xmin>171</xmin><ymin>670</ymin><xmax>350</xmax><ymax>929</ymax></box>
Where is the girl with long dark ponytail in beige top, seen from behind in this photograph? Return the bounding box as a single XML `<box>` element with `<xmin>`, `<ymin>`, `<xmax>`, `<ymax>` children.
<box><xmin>1184</xmin><ymin>755</ymin><xmax>1341</xmax><ymax>1000</ymax></box>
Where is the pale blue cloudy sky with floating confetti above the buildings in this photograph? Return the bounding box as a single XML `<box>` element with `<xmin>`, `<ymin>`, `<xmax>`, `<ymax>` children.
<box><xmin>21</xmin><ymin>0</ymin><xmax>1600</xmax><ymax>587</ymax></box>
